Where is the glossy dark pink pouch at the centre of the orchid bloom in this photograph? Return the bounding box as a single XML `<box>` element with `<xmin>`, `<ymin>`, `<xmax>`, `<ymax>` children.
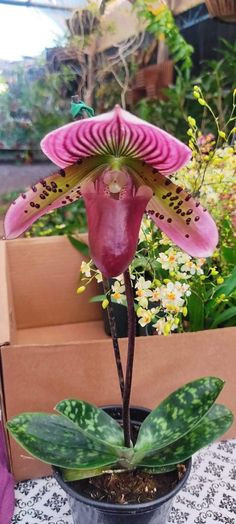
<box><xmin>82</xmin><ymin>171</ymin><xmax>152</xmax><ymax>278</ymax></box>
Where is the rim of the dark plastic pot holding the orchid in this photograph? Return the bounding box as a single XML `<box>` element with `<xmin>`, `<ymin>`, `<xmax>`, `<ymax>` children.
<box><xmin>52</xmin><ymin>405</ymin><xmax>192</xmax><ymax>513</ymax></box>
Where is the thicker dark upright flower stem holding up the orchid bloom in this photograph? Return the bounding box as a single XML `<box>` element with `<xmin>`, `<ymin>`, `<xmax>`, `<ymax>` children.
<box><xmin>123</xmin><ymin>269</ymin><xmax>136</xmax><ymax>448</ymax></box>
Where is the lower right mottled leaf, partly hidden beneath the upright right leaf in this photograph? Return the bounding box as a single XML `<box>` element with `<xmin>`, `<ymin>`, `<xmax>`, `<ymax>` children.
<box><xmin>135</xmin><ymin>404</ymin><xmax>233</xmax><ymax>468</ymax></box>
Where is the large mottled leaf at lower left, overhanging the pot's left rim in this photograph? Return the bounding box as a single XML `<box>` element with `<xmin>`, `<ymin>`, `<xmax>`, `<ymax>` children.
<box><xmin>7</xmin><ymin>413</ymin><xmax>120</xmax><ymax>469</ymax></box>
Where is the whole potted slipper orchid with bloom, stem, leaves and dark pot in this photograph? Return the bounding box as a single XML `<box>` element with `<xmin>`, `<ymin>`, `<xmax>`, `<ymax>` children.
<box><xmin>5</xmin><ymin>102</ymin><xmax>232</xmax><ymax>524</ymax></box>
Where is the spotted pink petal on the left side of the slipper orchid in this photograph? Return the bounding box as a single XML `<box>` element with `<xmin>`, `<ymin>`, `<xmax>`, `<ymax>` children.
<box><xmin>4</xmin><ymin>157</ymin><xmax>105</xmax><ymax>239</ymax></box>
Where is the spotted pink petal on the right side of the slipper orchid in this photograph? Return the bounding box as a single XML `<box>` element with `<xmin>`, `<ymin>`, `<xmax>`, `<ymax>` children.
<box><xmin>128</xmin><ymin>160</ymin><xmax>218</xmax><ymax>257</ymax></box>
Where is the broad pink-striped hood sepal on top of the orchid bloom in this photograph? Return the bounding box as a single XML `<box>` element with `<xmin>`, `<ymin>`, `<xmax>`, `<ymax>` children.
<box><xmin>41</xmin><ymin>106</ymin><xmax>191</xmax><ymax>175</ymax></box>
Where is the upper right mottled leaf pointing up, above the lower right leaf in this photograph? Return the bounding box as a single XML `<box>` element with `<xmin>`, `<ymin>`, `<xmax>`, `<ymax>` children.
<box><xmin>134</xmin><ymin>377</ymin><xmax>224</xmax><ymax>456</ymax></box>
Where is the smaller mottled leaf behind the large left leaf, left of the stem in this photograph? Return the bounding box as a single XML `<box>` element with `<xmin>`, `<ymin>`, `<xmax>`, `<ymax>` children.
<box><xmin>55</xmin><ymin>399</ymin><xmax>124</xmax><ymax>447</ymax></box>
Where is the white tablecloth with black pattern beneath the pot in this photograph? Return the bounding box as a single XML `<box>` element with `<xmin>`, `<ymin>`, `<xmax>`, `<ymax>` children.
<box><xmin>12</xmin><ymin>440</ymin><xmax>236</xmax><ymax>524</ymax></box>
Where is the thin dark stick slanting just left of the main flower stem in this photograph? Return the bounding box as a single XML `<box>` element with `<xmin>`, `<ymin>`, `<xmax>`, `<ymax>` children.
<box><xmin>103</xmin><ymin>277</ymin><xmax>124</xmax><ymax>399</ymax></box>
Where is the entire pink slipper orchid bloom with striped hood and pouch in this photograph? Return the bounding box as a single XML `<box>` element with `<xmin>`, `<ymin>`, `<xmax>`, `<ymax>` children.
<box><xmin>5</xmin><ymin>106</ymin><xmax>218</xmax><ymax>277</ymax></box>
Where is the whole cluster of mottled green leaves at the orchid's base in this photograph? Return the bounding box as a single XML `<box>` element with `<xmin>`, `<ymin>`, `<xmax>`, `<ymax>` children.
<box><xmin>7</xmin><ymin>377</ymin><xmax>233</xmax><ymax>481</ymax></box>
